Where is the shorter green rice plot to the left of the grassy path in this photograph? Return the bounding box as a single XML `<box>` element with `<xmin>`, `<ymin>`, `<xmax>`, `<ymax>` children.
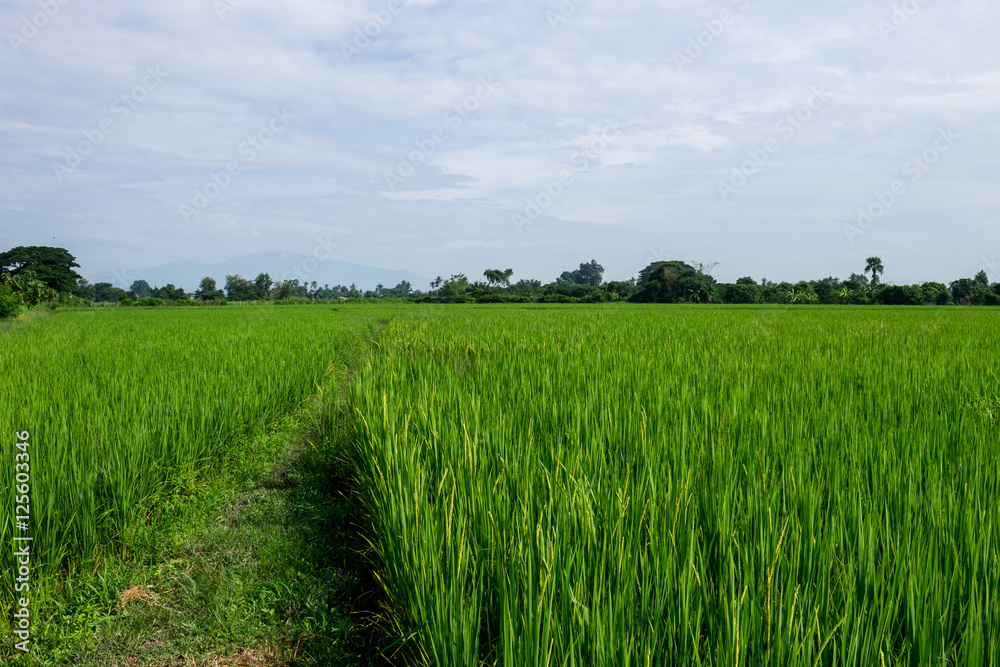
<box><xmin>0</xmin><ymin>307</ymin><xmax>374</xmax><ymax>608</ymax></box>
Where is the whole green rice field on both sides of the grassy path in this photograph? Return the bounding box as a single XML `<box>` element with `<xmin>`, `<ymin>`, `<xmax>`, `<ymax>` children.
<box><xmin>0</xmin><ymin>305</ymin><xmax>1000</xmax><ymax>667</ymax></box>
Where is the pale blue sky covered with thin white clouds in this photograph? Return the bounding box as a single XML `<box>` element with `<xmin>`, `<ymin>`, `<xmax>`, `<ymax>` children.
<box><xmin>0</xmin><ymin>0</ymin><xmax>1000</xmax><ymax>283</ymax></box>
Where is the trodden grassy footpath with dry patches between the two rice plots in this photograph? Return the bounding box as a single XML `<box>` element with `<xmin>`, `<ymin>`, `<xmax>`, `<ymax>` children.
<box><xmin>5</xmin><ymin>362</ymin><xmax>385</xmax><ymax>667</ymax></box>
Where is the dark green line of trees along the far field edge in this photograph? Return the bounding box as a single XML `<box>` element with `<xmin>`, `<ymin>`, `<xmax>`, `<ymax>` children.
<box><xmin>0</xmin><ymin>247</ymin><xmax>1000</xmax><ymax>318</ymax></box>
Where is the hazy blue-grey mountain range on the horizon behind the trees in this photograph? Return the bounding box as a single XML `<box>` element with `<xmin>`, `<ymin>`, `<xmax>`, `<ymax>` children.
<box><xmin>85</xmin><ymin>251</ymin><xmax>430</xmax><ymax>292</ymax></box>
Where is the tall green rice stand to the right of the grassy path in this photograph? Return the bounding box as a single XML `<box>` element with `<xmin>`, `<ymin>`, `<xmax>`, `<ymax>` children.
<box><xmin>352</xmin><ymin>307</ymin><xmax>1000</xmax><ymax>666</ymax></box>
